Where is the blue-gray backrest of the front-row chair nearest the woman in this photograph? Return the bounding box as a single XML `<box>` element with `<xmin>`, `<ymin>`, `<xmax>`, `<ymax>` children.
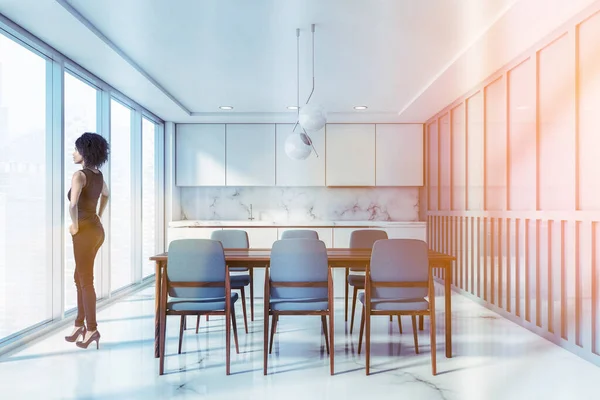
<box><xmin>167</xmin><ymin>239</ymin><xmax>226</xmax><ymax>298</ymax></box>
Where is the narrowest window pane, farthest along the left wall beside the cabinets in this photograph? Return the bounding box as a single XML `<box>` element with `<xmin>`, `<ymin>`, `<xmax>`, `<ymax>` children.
<box><xmin>142</xmin><ymin>118</ymin><xmax>156</xmax><ymax>277</ymax></box>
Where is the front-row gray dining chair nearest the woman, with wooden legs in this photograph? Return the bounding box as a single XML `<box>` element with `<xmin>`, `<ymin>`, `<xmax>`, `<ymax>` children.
<box><xmin>159</xmin><ymin>239</ymin><xmax>239</xmax><ymax>375</ymax></box>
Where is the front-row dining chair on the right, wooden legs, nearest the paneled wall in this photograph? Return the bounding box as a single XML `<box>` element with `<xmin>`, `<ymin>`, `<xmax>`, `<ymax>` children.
<box><xmin>358</xmin><ymin>239</ymin><xmax>437</xmax><ymax>375</ymax></box>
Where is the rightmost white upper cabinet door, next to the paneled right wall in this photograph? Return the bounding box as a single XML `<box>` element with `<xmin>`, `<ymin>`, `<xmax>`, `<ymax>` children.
<box><xmin>378</xmin><ymin>124</ymin><xmax>423</xmax><ymax>186</ymax></box>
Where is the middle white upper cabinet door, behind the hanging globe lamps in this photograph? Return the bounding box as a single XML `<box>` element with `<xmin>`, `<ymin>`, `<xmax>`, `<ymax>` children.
<box><xmin>275</xmin><ymin>124</ymin><xmax>325</xmax><ymax>186</ymax></box>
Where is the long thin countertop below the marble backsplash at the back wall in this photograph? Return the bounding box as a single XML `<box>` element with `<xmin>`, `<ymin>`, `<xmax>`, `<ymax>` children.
<box><xmin>169</xmin><ymin>220</ymin><xmax>426</xmax><ymax>228</ymax></box>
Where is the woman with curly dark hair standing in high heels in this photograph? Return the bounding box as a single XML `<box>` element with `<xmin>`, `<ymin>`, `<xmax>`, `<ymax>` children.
<box><xmin>65</xmin><ymin>132</ymin><xmax>109</xmax><ymax>349</ymax></box>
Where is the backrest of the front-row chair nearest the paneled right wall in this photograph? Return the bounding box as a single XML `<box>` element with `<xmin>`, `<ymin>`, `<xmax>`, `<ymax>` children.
<box><xmin>369</xmin><ymin>239</ymin><xmax>429</xmax><ymax>299</ymax></box>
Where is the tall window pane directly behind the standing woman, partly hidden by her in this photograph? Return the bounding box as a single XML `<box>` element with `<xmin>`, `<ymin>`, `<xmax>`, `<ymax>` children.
<box><xmin>64</xmin><ymin>73</ymin><xmax>100</xmax><ymax>310</ymax></box>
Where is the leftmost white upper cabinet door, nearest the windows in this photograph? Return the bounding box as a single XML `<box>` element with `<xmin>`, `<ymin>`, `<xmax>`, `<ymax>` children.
<box><xmin>175</xmin><ymin>124</ymin><xmax>225</xmax><ymax>186</ymax></box>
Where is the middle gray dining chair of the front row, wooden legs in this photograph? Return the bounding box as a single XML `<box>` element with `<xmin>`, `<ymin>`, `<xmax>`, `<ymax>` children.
<box><xmin>263</xmin><ymin>239</ymin><xmax>335</xmax><ymax>375</ymax></box>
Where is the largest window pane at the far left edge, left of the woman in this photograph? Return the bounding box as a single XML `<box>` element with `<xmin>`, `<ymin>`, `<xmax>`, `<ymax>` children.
<box><xmin>0</xmin><ymin>34</ymin><xmax>52</xmax><ymax>341</ymax></box>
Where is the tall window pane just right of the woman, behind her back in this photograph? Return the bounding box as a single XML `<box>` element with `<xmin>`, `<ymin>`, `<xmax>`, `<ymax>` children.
<box><xmin>109</xmin><ymin>99</ymin><xmax>134</xmax><ymax>290</ymax></box>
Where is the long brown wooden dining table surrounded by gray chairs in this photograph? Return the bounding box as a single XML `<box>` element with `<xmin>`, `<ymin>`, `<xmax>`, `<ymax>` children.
<box><xmin>150</xmin><ymin>248</ymin><xmax>456</xmax><ymax>358</ymax></box>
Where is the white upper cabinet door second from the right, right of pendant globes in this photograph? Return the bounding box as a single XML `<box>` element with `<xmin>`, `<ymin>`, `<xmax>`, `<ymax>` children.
<box><xmin>326</xmin><ymin>124</ymin><xmax>375</xmax><ymax>186</ymax></box>
